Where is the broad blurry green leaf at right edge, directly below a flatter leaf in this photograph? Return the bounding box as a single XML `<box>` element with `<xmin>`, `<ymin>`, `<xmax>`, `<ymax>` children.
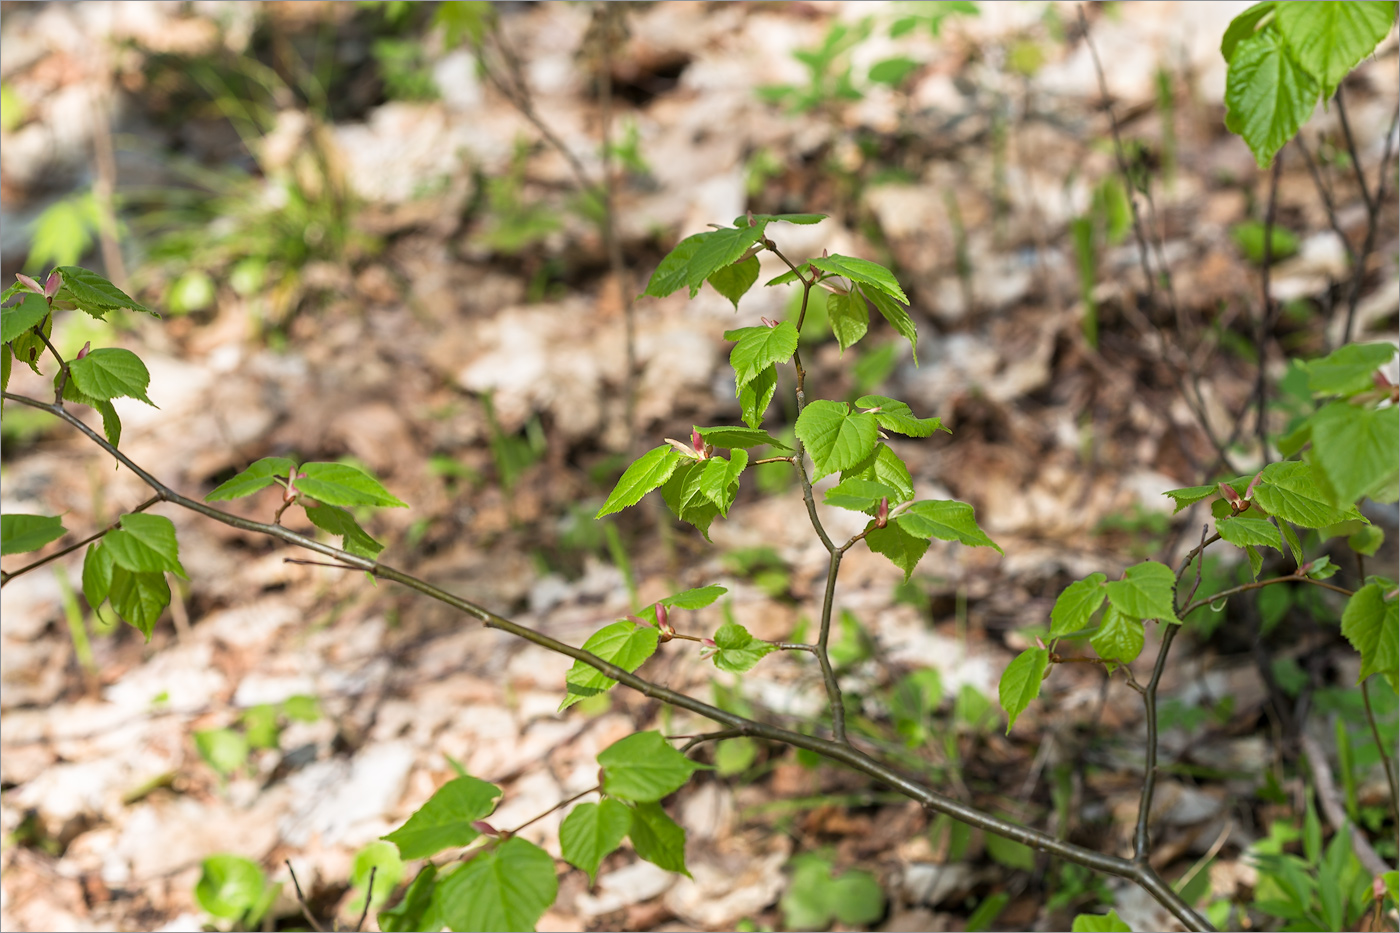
<box><xmin>1312</xmin><ymin>402</ymin><xmax>1400</xmax><ymax>507</ymax></box>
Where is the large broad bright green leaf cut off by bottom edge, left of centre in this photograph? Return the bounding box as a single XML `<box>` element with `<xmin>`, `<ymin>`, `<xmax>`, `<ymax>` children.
<box><xmin>433</xmin><ymin>836</ymin><xmax>559</xmax><ymax>932</ymax></box>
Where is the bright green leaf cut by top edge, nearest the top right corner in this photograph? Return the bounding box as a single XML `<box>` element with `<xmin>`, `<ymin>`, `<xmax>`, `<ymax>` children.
<box><xmin>1274</xmin><ymin>0</ymin><xmax>1396</xmax><ymax>94</ymax></box>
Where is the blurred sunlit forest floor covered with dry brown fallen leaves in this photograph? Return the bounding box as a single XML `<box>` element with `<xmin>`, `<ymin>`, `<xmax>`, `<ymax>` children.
<box><xmin>0</xmin><ymin>3</ymin><xmax>1400</xmax><ymax>930</ymax></box>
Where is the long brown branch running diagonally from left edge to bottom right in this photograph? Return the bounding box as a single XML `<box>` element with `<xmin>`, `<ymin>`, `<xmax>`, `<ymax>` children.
<box><xmin>0</xmin><ymin>383</ymin><xmax>1214</xmax><ymax>932</ymax></box>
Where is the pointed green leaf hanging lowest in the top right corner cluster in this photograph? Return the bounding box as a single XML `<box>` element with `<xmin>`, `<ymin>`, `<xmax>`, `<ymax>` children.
<box><xmin>1225</xmin><ymin>25</ymin><xmax>1320</xmax><ymax>168</ymax></box>
